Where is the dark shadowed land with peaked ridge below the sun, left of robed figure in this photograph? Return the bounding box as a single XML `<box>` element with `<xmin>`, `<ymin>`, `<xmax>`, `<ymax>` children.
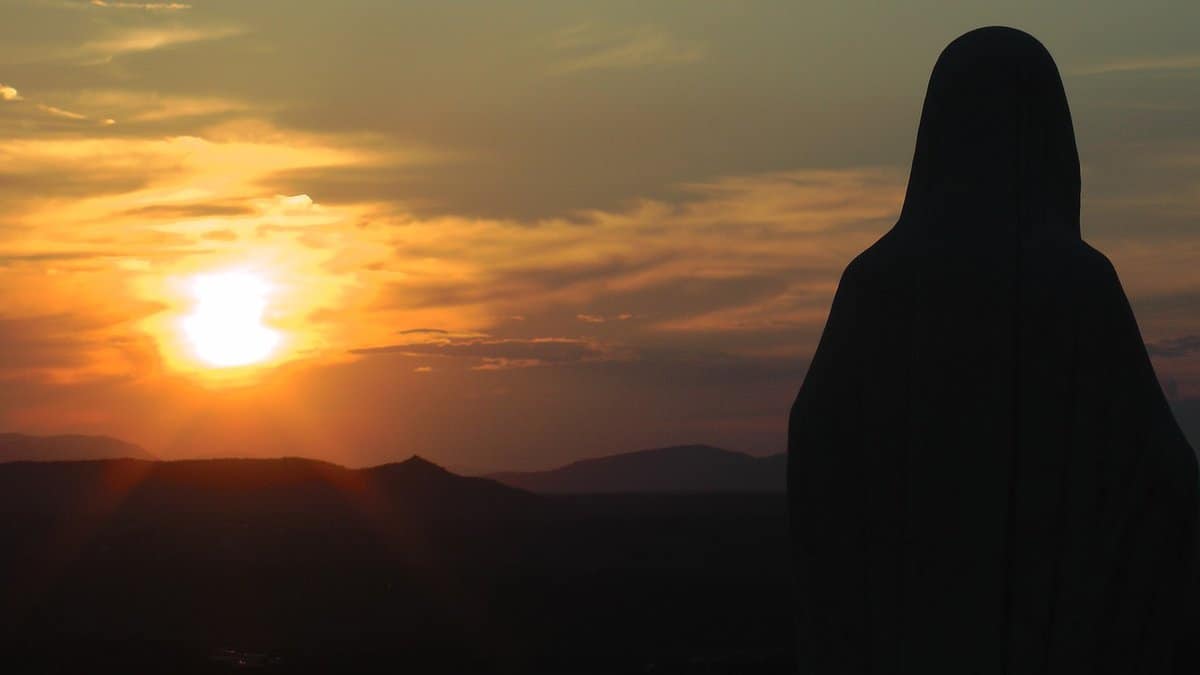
<box><xmin>0</xmin><ymin>459</ymin><xmax>791</xmax><ymax>674</ymax></box>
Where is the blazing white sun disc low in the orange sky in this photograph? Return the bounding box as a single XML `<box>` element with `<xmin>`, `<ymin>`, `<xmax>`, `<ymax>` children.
<box><xmin>182</xmin><ymin>271</ymin><xmax>281</xmax><ymax>368</ymax></box>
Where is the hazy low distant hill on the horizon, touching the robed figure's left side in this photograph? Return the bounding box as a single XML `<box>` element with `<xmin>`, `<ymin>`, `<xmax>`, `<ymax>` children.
<box><xmin>487</xmin><ymin>446</ymin><xmax>787</xmax><ymax>494</ymax></box>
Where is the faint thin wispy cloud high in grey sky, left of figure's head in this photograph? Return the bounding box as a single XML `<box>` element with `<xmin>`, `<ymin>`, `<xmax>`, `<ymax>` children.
<box><xmin>551</xmin><ymin>25</ymin><xmax>704</xmax><ymax>73</ymax></box>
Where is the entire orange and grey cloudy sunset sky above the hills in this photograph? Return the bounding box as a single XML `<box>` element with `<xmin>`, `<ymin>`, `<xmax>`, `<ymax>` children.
<box><xmin>0</xmin><ymin>0</ymin><xmax>1200</xmax><ymax>471</ymax></box>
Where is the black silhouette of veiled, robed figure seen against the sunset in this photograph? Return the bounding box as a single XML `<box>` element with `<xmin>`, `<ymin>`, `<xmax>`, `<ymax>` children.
<box><xmin>788</xmin><ymin>28</ymin><xmax>1200</xmax><ymax>675</ymax></box>
